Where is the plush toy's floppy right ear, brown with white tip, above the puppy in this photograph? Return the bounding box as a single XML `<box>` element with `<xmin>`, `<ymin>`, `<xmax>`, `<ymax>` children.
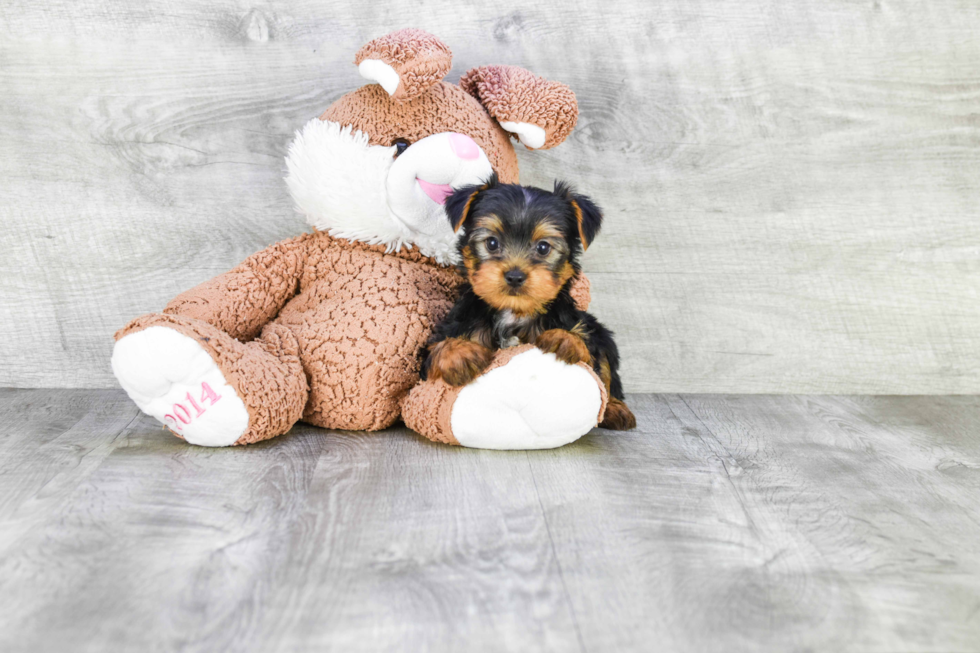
<box><xmin>459</xmin><ymin>66</ymin><xmax>578</xmax><ymax>150</ymax></box>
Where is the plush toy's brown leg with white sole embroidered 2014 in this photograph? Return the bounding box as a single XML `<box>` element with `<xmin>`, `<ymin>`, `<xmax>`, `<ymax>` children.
<box><xmin>112</xmin><ymin>315</ymin><xmax>309</xmax><ymax>447</ymax></box>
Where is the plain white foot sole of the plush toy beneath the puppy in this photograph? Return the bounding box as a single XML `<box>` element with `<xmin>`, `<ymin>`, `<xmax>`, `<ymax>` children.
<box><xmin>451</xmin><ymin>349</ymin><xmax>602</xmax><ymax>449</ymax></box>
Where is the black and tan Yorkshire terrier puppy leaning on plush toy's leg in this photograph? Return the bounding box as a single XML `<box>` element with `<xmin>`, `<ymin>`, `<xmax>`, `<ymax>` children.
<box><xmin>422</xmin><ymin>175</ymin><xmax>636</xmax><ymax>431</ymax></box>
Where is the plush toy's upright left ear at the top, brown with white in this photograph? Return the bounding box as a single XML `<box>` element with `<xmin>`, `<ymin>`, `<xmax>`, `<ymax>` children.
<box><xmin>354</xmin><ymin>28</ymin><xmax>453</xmax><ymax>102</ymax></box>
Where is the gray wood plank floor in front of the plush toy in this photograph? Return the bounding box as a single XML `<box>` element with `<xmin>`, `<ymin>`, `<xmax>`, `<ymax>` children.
<box><xmin>0</xmin><ymin>390</ymin><xmax>980</xmax><ymax>652</ymax></box>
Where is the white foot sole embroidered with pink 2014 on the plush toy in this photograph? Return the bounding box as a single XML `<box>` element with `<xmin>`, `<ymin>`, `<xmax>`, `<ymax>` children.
<box><xmin>112</xmin><ymin>326</ymin><xmax>248</xmax><ymax>447</ymax></box>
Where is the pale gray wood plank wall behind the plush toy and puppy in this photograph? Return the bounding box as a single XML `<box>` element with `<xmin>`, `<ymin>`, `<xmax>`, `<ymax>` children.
<box><xmin>0</xmin><ymin>0</ymin><xmax>980</xmax><ymax>393</ymax></box>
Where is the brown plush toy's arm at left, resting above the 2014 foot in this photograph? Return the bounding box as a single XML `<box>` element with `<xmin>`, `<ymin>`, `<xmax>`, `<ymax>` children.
<box><xmin>163</xmin><ymin>236</ymin><xmax>307</xmax><ymax>341</ymax></box>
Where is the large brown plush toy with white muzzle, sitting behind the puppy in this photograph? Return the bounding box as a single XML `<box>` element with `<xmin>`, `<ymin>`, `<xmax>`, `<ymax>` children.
<box><xmin>112</xmin><ymin>29</ymin><xmax>606</xmax><ymax>449</ymax></box>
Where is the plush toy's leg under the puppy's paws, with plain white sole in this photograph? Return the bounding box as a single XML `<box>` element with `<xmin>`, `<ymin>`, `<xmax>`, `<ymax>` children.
<box><xmin>402</xmin><ymin>345</ymin><xmax>606</xmax><ymax>449</ymax></box>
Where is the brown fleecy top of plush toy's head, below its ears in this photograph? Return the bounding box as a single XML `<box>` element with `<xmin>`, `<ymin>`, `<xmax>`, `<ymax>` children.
<box><xmin>320</xmin><ymin>82</ymin><xmax>518</xmax><ymax>184</ymax></box>
